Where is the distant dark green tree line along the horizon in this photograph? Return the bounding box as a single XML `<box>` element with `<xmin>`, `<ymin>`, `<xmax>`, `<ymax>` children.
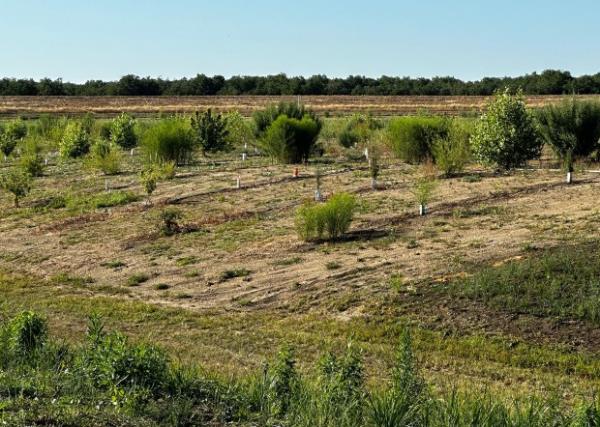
<box><xmin>0</xmin><ymin>70</ymin><xmax>600</xmax><ymax>96</ymax></box>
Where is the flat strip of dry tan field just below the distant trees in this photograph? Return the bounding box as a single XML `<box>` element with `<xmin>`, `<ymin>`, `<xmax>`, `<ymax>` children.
<box><xmin>0</xmin><ymin>95</ymin><xmax>600</xmax><ymax>117</ymax></box>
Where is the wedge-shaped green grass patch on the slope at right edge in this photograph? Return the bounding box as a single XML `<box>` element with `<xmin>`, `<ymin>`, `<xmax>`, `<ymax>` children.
<box><xmin>449</xmin><ymin>242</ymin><xmax>600</xmax><ymax>324</ymax></box>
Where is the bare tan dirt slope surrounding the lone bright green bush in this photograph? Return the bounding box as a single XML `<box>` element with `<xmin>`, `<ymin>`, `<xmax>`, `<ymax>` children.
<box><xmin>0</xmin><ymin>157</ymin><xmax>600</xmax><ymax>347</ymax></box>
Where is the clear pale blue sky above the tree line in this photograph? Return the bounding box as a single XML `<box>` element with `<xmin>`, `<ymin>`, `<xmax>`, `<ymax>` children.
<box><xmin>0</xmin><ymin>0</ymin><xmax>600</xmax><ymax>82</ymax></box>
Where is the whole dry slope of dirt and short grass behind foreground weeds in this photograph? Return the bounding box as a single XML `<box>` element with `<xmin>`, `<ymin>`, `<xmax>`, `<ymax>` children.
<box><xmin>0</xmin><ymin>147</ymin><xmax>600</xmax><ymax>397</ymax></box>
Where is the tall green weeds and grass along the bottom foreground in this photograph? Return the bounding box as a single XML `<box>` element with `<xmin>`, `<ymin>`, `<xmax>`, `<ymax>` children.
<box><xmin>0</xmin><ymin>312</ymin><xmax>600</xmax><ymax>427</ymax></box>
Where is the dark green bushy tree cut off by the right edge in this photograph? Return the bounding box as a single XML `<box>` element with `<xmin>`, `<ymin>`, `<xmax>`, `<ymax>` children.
<box><xmin>538</xmin><ymin>99</ymin><xmax>600</xmax><ymax>172</ymax></box>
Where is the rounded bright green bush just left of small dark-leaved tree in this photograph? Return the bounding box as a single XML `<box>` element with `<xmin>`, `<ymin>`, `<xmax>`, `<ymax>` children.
<box><xmin>142</xmin><ymin>117</ymin><xmax>196</xmax><ymax>165</ymax></box>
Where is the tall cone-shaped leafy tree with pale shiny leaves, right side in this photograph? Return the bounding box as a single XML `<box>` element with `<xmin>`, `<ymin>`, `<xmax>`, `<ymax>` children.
<box><xmin>471</xmin><ymin>89</ymin><xmax>543</xmax><ymax>169</ymax></box>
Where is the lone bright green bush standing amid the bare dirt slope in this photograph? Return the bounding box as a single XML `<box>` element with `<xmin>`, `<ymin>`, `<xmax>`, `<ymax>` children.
<box><xmin>296</xmin><ymin>193</ymin><xmax>356</xmax><ymax>241</ymax></box>
